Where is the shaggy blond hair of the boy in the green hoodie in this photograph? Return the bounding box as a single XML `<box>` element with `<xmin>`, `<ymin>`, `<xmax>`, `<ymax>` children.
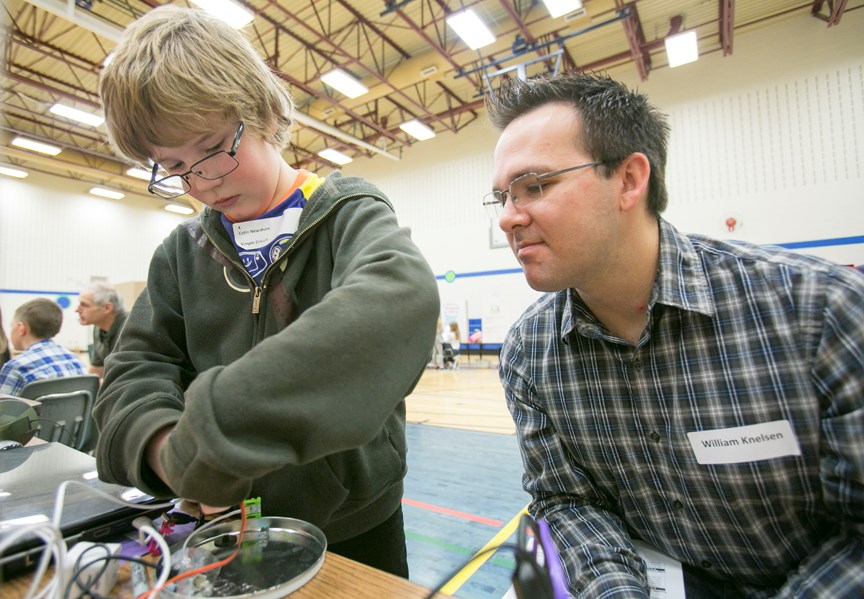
<box><xmin>99</xmin><ymin>5</ymin><xmax>294</xmax><ymax>165</ymax></box>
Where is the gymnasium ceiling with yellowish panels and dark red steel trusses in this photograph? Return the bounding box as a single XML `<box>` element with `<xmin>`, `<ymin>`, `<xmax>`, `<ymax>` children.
<box><xmin>0</xmin><ymin>0</ymin><xmax>864</xmax><ymax>211</ymax></box>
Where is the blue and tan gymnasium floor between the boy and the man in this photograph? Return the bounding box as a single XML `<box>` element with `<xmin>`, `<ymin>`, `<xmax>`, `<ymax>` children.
<box><xmin>403</xmin><ymin>368</ymin><xmax>529</xmax><ymax>599</ymax></box>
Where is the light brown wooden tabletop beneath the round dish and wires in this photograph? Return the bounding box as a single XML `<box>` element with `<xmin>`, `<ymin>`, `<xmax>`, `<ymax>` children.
<box><xmin>2</xmin><ymin>552</ymin><xmax>438</xmax><ymax>599</ymax></box>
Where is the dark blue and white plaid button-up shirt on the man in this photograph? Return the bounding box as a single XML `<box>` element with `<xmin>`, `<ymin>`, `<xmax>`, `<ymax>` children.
<box><xmin>500</xmin><ymin>219</ymin><xmax>864</xmax><ymax>598</ymax></box>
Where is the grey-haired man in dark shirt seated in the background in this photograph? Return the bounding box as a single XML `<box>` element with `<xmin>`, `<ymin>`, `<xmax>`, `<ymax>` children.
<box><xmin>75</xmin><ymin>283</ymin><xmax>127</xmax><ymax>377</ymax></box>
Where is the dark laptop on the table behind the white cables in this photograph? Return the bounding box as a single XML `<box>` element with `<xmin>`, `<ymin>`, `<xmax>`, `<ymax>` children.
<box><xmin>0</xmin><ymin>443</ymin><xmax>167</xmax><ymax>580</ymax></box>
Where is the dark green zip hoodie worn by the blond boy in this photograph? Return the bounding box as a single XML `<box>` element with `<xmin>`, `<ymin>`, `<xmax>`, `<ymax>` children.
<box><xmin>94</xmin><ymin>173</ymin><xmax>440</xmax><ymax>543</ymax></box>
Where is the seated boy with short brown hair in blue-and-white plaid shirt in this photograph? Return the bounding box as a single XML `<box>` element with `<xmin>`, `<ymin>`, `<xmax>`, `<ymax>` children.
<box><xmin>0</xmin><ymin>298</ymin><xmax>87</xmax><ymax>395</ymax></box>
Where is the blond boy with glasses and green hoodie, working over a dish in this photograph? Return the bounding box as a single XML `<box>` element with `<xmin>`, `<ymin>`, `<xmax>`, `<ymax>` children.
<box><xmin>95</xmin><ymin>6</ymin><xmax>439</xmax><ymax>577</ymax></box>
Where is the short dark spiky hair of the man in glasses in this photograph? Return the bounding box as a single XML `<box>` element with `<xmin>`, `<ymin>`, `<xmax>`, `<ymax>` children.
<box><xmin>486</xmin><ymin>72</ymin><xmax>669</xmax><ymax>216</ymax></box>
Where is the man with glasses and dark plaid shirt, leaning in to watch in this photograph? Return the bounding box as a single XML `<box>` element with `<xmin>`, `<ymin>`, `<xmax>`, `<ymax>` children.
<box><xmin>486</xmin><ymin>74</ymin><xmax>864</xmax><ymax>598</ymax></box>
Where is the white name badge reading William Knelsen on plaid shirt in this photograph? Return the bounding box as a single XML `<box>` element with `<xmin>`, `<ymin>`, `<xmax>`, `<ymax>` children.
<box><xmin>687</xmin><ymin>420</ymin><xmax>801</xmax><ymax>464</ymax></box>
